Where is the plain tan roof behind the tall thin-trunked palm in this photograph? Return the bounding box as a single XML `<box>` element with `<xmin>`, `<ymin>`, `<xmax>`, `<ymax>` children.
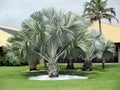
<box><xmin>90</xmin><ymin>22</ymin><xmax>120</xmax><ymax>43</ymax></box>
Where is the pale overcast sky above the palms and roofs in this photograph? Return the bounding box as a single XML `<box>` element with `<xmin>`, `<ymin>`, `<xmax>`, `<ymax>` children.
<box><xmin>0</xmin><ymin>0</ymin><xmax>120</xmax><ymax>28</ymax></box>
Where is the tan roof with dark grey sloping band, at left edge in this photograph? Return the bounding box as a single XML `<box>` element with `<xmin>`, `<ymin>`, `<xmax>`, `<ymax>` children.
<box><xmin>0</xmin><ymin>25</ymin><xmax>19</xmax><ymax>46</ymax></box>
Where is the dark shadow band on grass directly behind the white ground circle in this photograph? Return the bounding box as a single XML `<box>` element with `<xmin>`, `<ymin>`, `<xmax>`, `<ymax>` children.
<box><xmin>21</xmin><ymin>70</ymin><xmax>99</xmax><ymax>79</ymax></box>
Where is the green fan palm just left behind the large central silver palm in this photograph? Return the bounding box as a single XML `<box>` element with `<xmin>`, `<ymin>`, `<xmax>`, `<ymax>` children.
<box><xmin>20</xmin><ymin>19</ymin><xmax>44</xmax><ymax>70</ymax></box>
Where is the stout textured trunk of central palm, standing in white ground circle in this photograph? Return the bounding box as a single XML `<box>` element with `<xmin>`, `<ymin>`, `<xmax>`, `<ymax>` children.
<box><xmin>48</xmin><ymin>62</ymin><xmax>59</xmax><ymax>77</ymax></box>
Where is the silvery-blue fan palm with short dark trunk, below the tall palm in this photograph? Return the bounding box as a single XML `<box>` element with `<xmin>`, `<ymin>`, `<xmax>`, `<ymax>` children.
<box><xmin>77</xmin><ymin>30</ymin><xmax>103</xmax><ymax>71</ymax></box>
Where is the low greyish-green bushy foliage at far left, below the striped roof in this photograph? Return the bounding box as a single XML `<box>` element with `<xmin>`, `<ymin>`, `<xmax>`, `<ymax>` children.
<box><xmin>3</xmin><ymin>45</ymin><xmax>28</xmax><ymax>66</ymax></box>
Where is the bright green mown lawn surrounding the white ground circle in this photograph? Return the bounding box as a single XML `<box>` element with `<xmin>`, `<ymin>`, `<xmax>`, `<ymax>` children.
<box><xmin>0</xmin><ymin>64</ymin><xmax>120</xmax><ymax>90</ymax></box>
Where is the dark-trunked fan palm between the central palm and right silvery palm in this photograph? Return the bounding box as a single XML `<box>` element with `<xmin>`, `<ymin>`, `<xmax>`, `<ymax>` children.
<box><xmin>64</xmin><ymin>21</ymin><xmax>90</xmax><ymax>69</ymax></box>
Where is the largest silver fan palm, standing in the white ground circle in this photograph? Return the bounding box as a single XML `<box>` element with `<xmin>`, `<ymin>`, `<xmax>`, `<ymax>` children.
<box><xmin>26</xmin><ymin>8</ymin><xmax>89</xmax><ymax>77</ymax></box>
